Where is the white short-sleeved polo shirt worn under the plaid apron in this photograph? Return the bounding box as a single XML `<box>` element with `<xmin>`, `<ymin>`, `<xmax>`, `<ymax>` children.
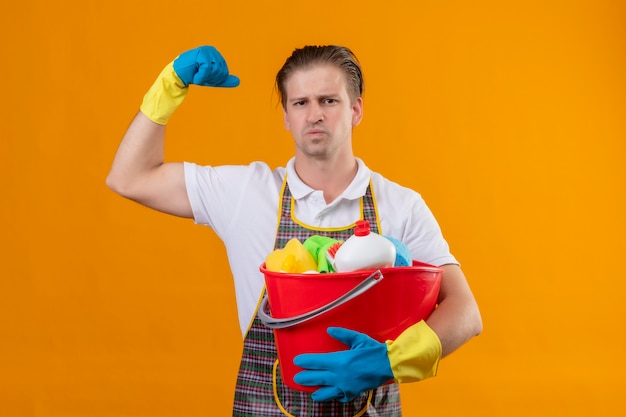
<box><xmin>185</xmin><ymin>158</ymin><xmax>457</xmax><ymax>336</ymax></box>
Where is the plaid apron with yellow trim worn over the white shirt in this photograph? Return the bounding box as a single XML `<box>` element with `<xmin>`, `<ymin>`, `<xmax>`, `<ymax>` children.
<box><xmin>233</xmin><ymin>179</ymin><xmax>401</xmax><ymax>417</ymax></box>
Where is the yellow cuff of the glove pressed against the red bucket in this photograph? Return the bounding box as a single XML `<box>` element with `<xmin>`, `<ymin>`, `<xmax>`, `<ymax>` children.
<box><xmin>386</xmin><ymin>320</ymin><xmax>441</xmax><ymax>383</ymax></box>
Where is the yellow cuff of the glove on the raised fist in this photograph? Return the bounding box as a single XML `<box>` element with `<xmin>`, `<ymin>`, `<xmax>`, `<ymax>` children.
<box><xmin>139</xmin><ymin>62</ymin><xmax>189</xmax><ymax>125</ymax></box>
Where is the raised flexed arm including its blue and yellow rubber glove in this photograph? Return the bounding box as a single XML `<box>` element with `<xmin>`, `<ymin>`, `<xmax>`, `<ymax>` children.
<box><xmin>106</xmin><ymin>46</ymin><xmax>239</xmax><ymax>218</ymax></box>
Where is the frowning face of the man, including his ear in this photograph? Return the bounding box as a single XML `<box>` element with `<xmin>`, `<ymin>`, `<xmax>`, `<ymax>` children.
<box><xmin>284</xmin><ymin>65</ymin><xmax>363</xmax><ymax>160</ymax></box>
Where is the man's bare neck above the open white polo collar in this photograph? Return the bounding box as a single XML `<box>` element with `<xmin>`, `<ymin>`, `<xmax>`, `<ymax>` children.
<box><xmin>295</xmin><ymin>154</ymin><xmax>358</xmax><ymax>203</ymax></box>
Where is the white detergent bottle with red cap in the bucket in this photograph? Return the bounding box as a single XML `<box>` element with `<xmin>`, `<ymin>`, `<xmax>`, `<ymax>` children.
<box><xmin>334</xmin><ymin>220</ymin><xmax>396</xmax><ymax>272</ymax></box>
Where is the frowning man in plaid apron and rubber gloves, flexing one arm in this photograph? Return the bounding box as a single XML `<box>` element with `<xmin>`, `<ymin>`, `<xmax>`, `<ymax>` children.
<box><xmin>107</xmin><ymin>46</ymin><xmax>482</xmax><ymax>416</ymax></box>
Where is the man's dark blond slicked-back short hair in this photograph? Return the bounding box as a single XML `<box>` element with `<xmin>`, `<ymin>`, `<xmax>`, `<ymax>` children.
<box><xmin>276</xmin><ymin>45</ymin><xmax>365</xmax><ymax>108</ymax></box>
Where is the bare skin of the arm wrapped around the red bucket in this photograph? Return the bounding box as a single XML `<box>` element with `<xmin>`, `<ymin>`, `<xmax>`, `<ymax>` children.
<box><xmin>426</xmin><ymin>265</ymin><xmax>483</xmax><ymax>357</ymax></box>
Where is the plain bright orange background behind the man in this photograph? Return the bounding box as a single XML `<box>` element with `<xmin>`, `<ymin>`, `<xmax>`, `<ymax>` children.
<box><xmin>0</xmin><ymin>0</ymin><xmax>626</xmax><ymax>417</ymax></box>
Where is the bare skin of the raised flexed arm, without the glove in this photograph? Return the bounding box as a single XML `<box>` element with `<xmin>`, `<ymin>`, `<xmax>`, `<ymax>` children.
<box><xmin>106</xmin><ymin>112</ymin><xmax>193</xmax><ymax>218</ymax></box>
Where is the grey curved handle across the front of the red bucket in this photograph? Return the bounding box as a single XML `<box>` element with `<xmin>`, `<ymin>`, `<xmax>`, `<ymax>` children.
<box><xmin>258</xmin><ymin>270</ymin><xmax>383</xmax><ymax>329</ymax></box>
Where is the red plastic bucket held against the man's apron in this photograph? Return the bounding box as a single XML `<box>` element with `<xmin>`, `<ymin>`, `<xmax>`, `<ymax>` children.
<box><xmin>258</xmin><ymin>261</ymin><xmax>443</xmax><ymax>392</ymax></box>
